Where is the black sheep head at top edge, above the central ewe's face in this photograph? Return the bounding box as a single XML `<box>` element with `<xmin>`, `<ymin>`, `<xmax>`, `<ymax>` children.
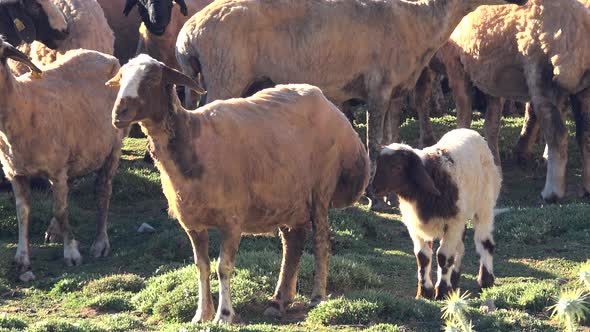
<box><xmin>123</xmin><ymin>0</ymin><xmax>188</xmax><ymax>36</ymax></box>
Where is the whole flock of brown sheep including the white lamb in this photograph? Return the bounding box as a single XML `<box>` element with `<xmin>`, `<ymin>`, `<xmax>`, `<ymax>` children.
<box><xmin>0</xmin><ymin>0</ymin><xmax>590</xmax><ymax>323</ymax></box>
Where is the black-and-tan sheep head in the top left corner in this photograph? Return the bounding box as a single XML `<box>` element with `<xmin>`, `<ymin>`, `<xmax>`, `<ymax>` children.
<box><xmin>0</xmin><ymin>0</ymin><xmax>68</xmax><ymax>49</ymax></box>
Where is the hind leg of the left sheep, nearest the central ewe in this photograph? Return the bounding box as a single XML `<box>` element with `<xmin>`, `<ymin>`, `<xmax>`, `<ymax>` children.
<box><xmin>90</xmin><ymin>148</ymin><xmax>121</xmax><ymax>257</ymax></box>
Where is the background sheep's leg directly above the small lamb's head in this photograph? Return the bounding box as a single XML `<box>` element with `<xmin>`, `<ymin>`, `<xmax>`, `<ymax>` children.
<box><xmin>414</xmin><ymin>68</ymin><xmax>436</xmax><ymax>147</ymax></box>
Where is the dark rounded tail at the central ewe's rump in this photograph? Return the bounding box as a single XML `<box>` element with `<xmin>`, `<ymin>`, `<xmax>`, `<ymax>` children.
<box><xmin>331</xmin><ymin>143</ymin><xmax>369</xmax><ymax>208</ymax></box>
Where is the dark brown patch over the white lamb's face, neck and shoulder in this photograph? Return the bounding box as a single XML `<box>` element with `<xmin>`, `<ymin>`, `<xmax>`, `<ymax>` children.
<box><xmin>373</xmin><ymin>149</ymin><xmax>459</xmax><ymax>223</ymax></box>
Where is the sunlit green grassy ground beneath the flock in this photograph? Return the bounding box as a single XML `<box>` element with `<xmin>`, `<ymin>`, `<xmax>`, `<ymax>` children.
<box><xmin>0</xmin><ymin>116</ymin><xmax>590</xmax><ymax>332</ymax></box>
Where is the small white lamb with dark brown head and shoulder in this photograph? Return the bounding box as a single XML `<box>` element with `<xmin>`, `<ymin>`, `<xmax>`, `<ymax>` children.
<box><xmin>374</xmin><ymin>129</ymin><xmax>502</xmax><ymax>299</ymax></box>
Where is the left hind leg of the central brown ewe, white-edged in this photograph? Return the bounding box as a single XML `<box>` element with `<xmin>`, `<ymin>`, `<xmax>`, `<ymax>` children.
<box><xmin>264</xmin><ymin>227</ymin><xmax>305</xmax><ymax>317</ymax></box>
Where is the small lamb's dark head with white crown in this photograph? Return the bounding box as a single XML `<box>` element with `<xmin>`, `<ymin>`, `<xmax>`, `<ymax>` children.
<box><xmin>373</xmin><ymin>143</ymin><xmax>441</xmax><ymax>196</ymax></box>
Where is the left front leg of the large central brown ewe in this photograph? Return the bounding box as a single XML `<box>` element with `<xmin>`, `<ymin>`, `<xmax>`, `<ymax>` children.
<box><xmin>186</xmin><ymin>230</ymin><xmax>215</xmax><ymax>323</ymax></box>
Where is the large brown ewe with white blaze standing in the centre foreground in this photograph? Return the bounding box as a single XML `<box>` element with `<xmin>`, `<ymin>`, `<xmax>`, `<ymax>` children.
<box><xmin>107</xmin><ymin>54</ymin><xmax>369</xmax><ymax>322</ymax></box>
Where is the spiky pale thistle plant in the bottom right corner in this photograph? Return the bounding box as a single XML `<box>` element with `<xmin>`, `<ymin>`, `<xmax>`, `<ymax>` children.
<box><xmin>549</xmin><ymin>289</ymin><xmax>590</xmax><ymax>332</ymax></box>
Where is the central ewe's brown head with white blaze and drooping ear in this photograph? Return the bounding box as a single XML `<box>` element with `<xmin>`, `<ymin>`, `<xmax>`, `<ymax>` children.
<box><xmin>106</xmin><ymin>54</ymin><xmax>205</xmax><ymax>128</ymax></box>
